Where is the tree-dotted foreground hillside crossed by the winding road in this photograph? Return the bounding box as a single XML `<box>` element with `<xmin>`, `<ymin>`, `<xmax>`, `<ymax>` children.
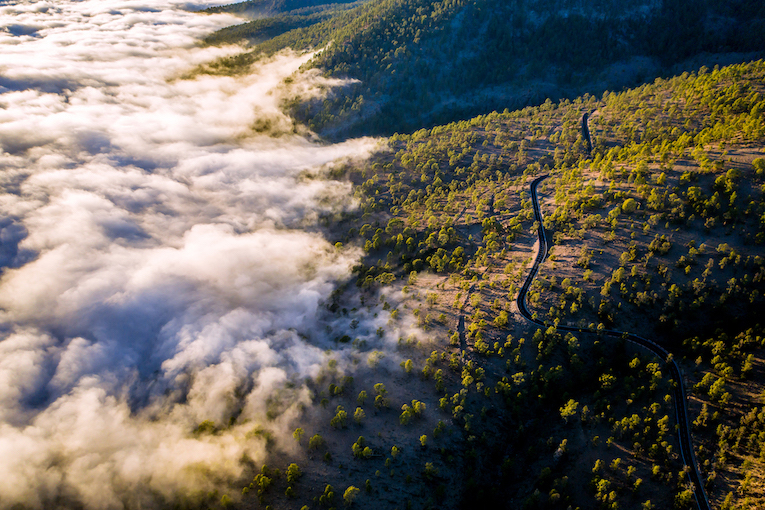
<box><xmin>218</xmin><ymin>61</ymin><xmax>765</xmax><ymax>509</ymax></box>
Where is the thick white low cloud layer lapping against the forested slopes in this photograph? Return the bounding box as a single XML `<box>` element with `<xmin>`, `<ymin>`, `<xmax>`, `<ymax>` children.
<box><xmin>0</xmin><ymin>0</ymin><xmax>382</xmax><ymax>509</ymax></box>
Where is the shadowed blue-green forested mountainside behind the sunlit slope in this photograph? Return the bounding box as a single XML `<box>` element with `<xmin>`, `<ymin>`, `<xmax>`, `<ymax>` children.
<box><xmin>200</xmin><ymin>0</ymin><xmax>765</xmax><ymax>138</ymax></box>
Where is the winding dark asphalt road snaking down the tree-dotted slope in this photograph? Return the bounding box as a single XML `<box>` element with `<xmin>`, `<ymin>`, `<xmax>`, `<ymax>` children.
<box><xmin>517</xmin><ymin>174</ymin><xmax>711</xmax><ymax>510</ymax></box>
